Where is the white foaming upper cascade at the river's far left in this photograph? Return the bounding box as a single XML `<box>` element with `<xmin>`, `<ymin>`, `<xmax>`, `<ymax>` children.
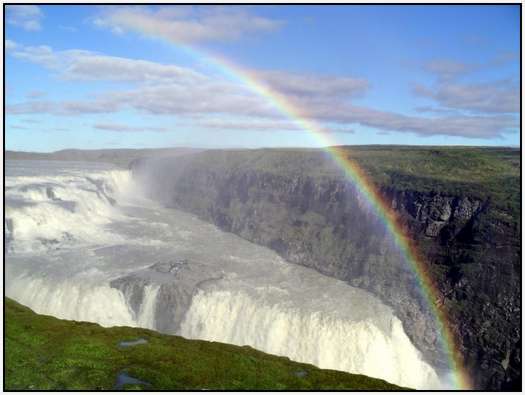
<box><xmin>4</xmin><ymin>170</ymin><xmax>134</xmax><ymax>252</ymax></box>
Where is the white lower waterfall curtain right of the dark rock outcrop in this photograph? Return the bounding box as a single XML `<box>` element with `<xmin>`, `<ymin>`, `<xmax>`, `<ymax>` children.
<box><xmin>180</xmin><ymin>290</ymin><xmax>439</xmax><ymax>389</ymax></box>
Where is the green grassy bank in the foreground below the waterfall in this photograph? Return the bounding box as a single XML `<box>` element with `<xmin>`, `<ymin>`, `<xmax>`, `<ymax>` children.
<box><xmin>4</xmin><ymin>298</ymin><xmax>404</xmax><ymax>390</ymax></box>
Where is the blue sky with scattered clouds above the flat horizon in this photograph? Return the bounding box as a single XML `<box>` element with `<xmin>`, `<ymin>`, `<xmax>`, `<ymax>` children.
<box><xmin>4</xmin><ymin>5</ymin><xmax>520</xmax><ymax>152</ymax></box>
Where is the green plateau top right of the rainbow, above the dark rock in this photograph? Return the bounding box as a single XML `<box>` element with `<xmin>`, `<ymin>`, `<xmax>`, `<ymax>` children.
<box><xmin>346</xmin><ymin>146</ymin><xmax>521</xmax><ymax>196</ymax></box>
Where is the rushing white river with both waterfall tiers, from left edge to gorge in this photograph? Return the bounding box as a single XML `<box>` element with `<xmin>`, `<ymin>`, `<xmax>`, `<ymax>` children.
<box><xmin>4</xmin><ymin>161</ymin><xmax>441</xmax><ymax>388</ymax></box>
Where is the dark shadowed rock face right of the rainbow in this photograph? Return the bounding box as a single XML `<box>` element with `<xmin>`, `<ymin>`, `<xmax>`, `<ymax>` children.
<box><xmin>383</xmin><ymin>189</ymin><xmax>521</xmax><ymax>390</ymax></box>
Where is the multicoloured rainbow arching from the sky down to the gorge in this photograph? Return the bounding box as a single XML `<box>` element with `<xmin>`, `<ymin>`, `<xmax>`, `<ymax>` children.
<box><xmin>170</xmin><ymin>41</ymin><xmax>472</xmax><ymax>390</ymax></box>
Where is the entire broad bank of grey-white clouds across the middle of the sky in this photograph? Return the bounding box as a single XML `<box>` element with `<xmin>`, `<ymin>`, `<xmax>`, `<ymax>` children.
<box><xmin>6</xmin><ymin>45</ymin><xmax>519</xmax><ymax>138</ymax></box>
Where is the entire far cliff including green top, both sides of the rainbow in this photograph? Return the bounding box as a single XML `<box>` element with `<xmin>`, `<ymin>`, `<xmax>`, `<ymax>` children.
<box><xmin>132</xmin><ymin>147</ymin><xmax>521</xmax><ymax>389</ymax></box>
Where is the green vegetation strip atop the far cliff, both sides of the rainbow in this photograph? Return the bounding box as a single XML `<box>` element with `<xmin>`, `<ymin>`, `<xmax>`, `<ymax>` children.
<box><xmin>175</xmin><ymin>145</ymin><xmax>521</xmax><ymax>221</ymax></box>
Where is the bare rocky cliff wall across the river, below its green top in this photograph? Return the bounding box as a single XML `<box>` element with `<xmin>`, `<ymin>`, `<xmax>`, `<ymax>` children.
<box><xmin>132</xmin><ymin>150</ymin><xmax>521</xmax><ymax>389</ymax></box>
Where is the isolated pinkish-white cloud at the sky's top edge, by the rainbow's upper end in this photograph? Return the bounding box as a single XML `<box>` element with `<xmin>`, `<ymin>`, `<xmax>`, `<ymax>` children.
<box><xmin>93</xmin><ymin>5</ymin><xmax>283</xmax><ymax>43</ymax></box>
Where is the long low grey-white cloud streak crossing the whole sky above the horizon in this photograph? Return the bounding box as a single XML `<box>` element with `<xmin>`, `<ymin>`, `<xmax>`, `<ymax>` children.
<box><xmin>6</xmin><ymin>87</ymin><xmax>519</xmax><ymax>138</ymax></box>
